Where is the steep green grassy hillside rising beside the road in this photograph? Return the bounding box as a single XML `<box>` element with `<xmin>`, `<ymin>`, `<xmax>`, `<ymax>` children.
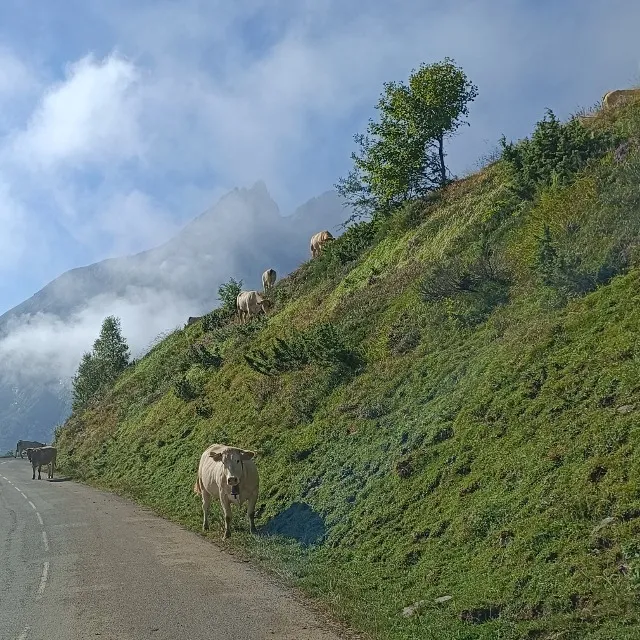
<box><xmin>56</xmin><ymin>96</ymin><xmax>640</xmax><ymax>640</ymax></box>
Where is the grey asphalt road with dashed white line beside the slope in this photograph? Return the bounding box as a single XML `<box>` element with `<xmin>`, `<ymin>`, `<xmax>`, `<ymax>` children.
<box><xmin>0</xmin><ymin>458</ymin><xmax>339</xmax><ymax>640</ymax></box>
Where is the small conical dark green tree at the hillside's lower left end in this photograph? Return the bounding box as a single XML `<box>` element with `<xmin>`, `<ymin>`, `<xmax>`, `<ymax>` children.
<box><xmin>73</xmin><ymin>316</ymin><xmax>130</xmax><ymax>410</ymax></box>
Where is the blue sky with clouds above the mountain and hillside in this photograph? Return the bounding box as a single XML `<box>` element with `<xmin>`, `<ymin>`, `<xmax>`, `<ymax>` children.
<box><xmin>0</xmin><ymin>0</ymin><xmax>640</xmax><ymax>312</ymax></box>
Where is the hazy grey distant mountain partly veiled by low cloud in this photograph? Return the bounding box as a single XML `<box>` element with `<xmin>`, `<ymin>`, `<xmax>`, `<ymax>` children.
<box><xmin>0</xmin><ymin>182</ymin><xmax>348</xmax><ymax>450</ymax></box>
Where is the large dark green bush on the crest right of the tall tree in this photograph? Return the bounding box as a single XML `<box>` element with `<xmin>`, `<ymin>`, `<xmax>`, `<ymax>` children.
<box><xmin>500</xmin><ymin>109</ymin><xmax>615</xmax><ymax>198</ymax></box>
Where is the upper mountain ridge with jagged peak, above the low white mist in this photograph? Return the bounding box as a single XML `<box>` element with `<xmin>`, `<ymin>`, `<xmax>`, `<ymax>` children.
<box><xmin>0</xmin><ymin>181</ymin><xmax>347</xmax><ymax>328</ymax></box>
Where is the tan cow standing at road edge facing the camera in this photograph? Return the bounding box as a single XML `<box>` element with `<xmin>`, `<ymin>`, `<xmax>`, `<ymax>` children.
<box><xmin>193</xmin><ymin>444</ymin><xmax>260</xmax><ymax>540</ymax></box>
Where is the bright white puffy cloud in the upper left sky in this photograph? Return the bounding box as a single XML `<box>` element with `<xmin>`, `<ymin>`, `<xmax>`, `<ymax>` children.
<box><xmin>13</xmin><ymin>54</ymin><xmax>142</xmax><ymax>170</ymax></box>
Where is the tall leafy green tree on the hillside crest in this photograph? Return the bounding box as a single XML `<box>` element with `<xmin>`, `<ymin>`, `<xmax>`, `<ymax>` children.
<box><xmin>336</xmin><ymin>58</ymin><xmax>478</xmax><ymax>219</ymax></box>
